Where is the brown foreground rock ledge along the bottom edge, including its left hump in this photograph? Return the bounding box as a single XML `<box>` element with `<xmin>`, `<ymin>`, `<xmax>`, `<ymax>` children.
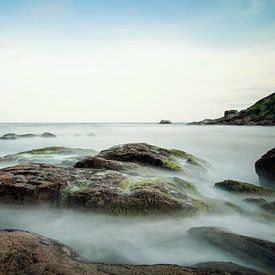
<box><xmin>0</xmin><ymin>229</ymin><xmax>263</xmax><ymax>275</ymax></box>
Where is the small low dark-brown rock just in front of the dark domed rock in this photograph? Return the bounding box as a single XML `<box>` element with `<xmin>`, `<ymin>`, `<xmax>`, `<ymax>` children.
<box><xmin>74</xmin><ymin>157</ymin><xmax>134</xmax><ymax>171</ymax></box>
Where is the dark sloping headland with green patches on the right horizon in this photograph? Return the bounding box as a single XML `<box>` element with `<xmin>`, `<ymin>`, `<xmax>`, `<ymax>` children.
<box><xmin>189</xmin><ymin>93</ymin><xmax>275</xmax><ymax>125</ymax></box>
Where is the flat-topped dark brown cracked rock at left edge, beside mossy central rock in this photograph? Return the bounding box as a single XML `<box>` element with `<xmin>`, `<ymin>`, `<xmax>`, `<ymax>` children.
<box><xmin>0</xmin><ymin>164</ymin><xmax>67</xmax><ymax>204</ymax></box>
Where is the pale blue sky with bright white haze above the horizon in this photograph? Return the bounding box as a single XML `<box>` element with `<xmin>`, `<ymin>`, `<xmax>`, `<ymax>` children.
<box><xmin>0</xmin><ymin>0</ymin><xmax>275</xmax><ymax>122</ymax></box>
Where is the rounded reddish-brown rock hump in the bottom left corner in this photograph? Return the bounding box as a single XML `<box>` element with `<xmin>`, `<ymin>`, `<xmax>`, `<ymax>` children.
<box><xmin>0</xmin><ymin>230</ymin><xmax>97</xmax><ymax>274</ymax></box>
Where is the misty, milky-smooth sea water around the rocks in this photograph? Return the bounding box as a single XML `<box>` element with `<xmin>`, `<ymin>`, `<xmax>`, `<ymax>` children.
<box><xmin>0</xmin><ymin>123</ymin><xmax>275</xmax><ymax>270</ymax></box>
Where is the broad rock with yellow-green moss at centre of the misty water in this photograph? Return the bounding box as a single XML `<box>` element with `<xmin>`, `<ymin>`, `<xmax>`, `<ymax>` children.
<box><xmin>62</xmin><ymin>170</ymin><xmax>206</xmax><ymax>215</ymax></box>
